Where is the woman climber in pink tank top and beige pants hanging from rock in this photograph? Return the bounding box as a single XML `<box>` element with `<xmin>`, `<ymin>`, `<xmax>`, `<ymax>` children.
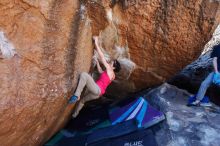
<box><xmin>69</xmin><ymin>37</ymin><xmax>121</xmax><ymax>118</ymax></box>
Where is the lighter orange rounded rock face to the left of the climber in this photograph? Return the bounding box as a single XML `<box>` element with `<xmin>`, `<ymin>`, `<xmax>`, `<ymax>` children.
<box><xmin>0</xmin><ymin>0</ymin><xmax>93</xmax><ymax>146</ymax></box>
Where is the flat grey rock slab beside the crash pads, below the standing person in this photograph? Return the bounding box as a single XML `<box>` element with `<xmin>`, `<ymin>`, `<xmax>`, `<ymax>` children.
<box><xmin>146</xmin><ymin>84</ymin><xmax>220</xmax><ymax>146</ymax></box>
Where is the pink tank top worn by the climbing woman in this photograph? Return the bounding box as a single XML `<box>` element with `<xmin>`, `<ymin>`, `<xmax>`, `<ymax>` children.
<box><xmin>96</xmin><ymin>71</ymin><xmax>111</xmax><ymax>95</ymax></box>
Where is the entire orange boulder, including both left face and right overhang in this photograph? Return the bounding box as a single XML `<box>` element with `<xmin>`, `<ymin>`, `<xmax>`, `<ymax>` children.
<box><xmin>0</xmin><ymin>0</ymin><xmax>220</xmax><ymax>146</ymax></box>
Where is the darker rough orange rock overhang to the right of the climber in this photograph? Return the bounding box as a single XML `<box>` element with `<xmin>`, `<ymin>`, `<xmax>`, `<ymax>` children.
<box><xmin>85</xmin><ymin>0</ymin><xmax>220</xmax><ymax>92</ymax></box>
